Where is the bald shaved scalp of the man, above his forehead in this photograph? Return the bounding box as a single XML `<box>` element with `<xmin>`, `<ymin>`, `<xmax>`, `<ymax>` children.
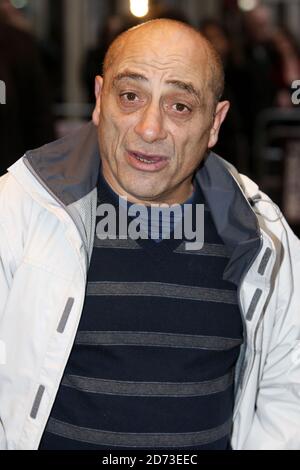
<box><xmin>103</xmin><ymin>19</ymin><xmax>224</xmax><ymax>105</ymax></box>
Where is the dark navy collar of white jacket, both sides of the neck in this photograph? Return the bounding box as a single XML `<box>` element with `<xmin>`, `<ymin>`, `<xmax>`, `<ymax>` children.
<box><xmin>24</xmin><ymin>122</ymin><xmax>261</xmax><ymax>285</ymax></box>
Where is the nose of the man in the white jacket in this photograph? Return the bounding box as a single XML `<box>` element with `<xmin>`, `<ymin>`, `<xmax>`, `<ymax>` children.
<box><xmin>135</xmin><ymin>102</ymin><xmax>167</xmax><ymax>143</ymax></box>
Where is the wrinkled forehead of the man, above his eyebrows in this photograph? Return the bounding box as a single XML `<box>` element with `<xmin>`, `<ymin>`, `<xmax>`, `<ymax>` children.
<box><xmin>105</xmin><ymin>29</ymin><xmax>209</xmax><ymax>88</ymax></box>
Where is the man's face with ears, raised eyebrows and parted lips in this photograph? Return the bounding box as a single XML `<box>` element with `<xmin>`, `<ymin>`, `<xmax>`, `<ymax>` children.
<box><xmin>93</xmin><ymin>24</ymin><xmax>228</xmax><ymax>204</ymax></box>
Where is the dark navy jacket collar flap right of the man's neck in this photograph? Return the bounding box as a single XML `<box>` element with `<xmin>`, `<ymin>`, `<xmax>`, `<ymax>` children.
<box><xmin>196</xmin><ymin>156</ymin><xmax>262</xmax><ymax>285</ymax></box>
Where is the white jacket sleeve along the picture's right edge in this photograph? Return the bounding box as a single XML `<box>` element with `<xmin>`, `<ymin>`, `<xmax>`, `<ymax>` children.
<box><xmin>243</xmin><ymin>213</ymin><xmax>300</xmax><ymax>450</ymax></box>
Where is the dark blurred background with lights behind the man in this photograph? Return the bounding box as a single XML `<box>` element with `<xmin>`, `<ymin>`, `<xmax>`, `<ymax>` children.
<box><xmin>0</xmin><ymin>0</ymin><xmax>300</xmax><ymax>235</ymax></box>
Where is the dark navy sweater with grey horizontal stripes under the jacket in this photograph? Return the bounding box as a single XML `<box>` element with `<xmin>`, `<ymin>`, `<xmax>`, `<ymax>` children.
<box><xmin>39</xmin><ymin>171</ymin><xmax>242</xmax><ymax>450</ymax></box>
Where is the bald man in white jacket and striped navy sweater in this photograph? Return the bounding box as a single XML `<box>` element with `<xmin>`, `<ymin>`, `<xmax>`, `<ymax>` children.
<box><xmin>0</xmin><ymin>20</ymin><xmax>300</xmax><ymax>450</ymax></box>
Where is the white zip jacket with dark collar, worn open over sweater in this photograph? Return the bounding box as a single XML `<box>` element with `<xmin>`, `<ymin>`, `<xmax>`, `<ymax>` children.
<box><xmin>0</xmin><ymin>123</ymin><xmax>300</xmax><ymax>450</ymax></box>
